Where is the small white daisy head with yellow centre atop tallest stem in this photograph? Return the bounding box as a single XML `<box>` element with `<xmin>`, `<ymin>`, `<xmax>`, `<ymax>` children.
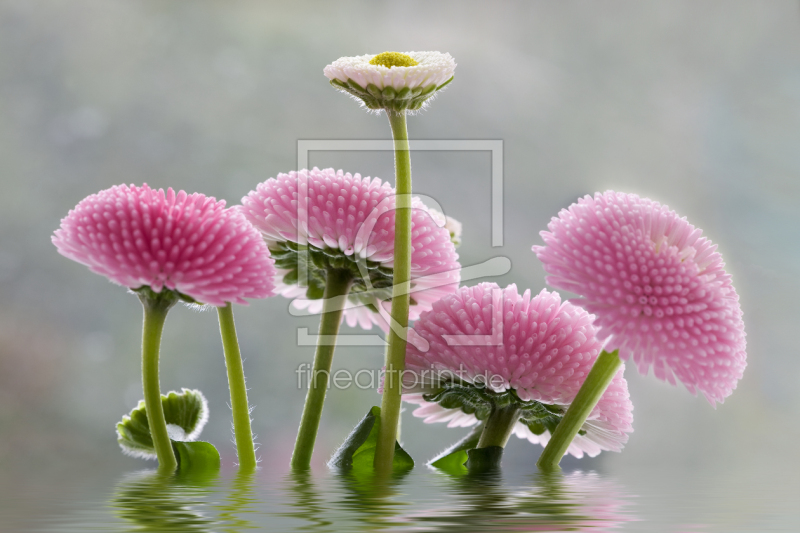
<box><xmin>324</xmin><ymin>52</ymin><xmax>456</xmax><ymax>111</ymax></box>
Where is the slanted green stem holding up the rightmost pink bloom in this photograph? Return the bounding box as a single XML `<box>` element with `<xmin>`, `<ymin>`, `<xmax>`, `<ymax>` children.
<box><xmin>536</xmin><ymin>350</ymin><xmax>622</xmax><ymax>470</ymax></box>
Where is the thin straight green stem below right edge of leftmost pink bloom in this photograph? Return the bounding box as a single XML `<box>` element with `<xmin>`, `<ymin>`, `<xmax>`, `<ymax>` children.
<box><xmin>217</xmin><ymin>303</ymin><xmax>257</xmax><ymax>470</ymax></box>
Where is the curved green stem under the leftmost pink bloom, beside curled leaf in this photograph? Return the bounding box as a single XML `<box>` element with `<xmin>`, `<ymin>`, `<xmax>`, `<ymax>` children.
<box><xmin>139</xmin><ymin>290</ymin><xmax>178</xmax><ymax>472</ymax></box>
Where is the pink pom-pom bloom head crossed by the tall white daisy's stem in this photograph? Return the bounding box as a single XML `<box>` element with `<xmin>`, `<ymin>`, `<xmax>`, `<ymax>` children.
<box><xmin>242</xmin><ymin>168</ymin><xmax>461</xmax><ymax>331</ymax></box>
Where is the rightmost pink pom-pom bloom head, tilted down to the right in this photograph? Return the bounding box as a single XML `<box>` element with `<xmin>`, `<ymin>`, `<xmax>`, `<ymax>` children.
<box><xmin>533</xmin><ymin>191</ymin><xmax>746</xmax><ymax>405</ymax></box>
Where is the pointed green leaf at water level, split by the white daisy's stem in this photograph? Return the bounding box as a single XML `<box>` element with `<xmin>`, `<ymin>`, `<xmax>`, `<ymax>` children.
<box><xmin>328</xmin><ymin>407</ymin><xmax>414</xmax><ymax>473</ymax></box>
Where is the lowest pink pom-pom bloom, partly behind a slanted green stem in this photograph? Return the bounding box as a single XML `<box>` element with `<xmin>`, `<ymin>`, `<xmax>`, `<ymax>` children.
<box><xmin>403</xmin><ymin>283</ymin><xmax>633</xmax><ymax>458</ymax></box>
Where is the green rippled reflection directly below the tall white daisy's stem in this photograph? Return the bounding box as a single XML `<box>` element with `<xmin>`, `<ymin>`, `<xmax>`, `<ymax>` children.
<box><xmin>336</xmin><ymin>471</ymin><xmax>410</xmax><ymax>531</ymax></box>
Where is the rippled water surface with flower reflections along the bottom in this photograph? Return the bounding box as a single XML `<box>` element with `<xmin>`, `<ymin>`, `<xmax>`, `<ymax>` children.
<box><xmin>0</xmin><ymin>460</ymin><xmax>800</xmax><ymax>533</ymax></box>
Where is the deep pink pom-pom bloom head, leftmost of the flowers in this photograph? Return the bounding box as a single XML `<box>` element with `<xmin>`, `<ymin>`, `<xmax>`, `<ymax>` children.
<box><xmin>53</xmin><ymin>184</ymin><xmax>275</xmax><ymax>307</ymax></box>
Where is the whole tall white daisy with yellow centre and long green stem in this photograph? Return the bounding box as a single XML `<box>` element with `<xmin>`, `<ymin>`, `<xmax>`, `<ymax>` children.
<box><xmin>324</xmin><ymin>52</ymin><xmax>456</xmax><ymax>474</ymax></box>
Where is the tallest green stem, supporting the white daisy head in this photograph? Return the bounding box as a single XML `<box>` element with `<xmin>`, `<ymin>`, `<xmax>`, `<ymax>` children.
<box><xmin>375</xmin><ymin>110</ymin><xmax>411</xmax><ymax>474</ymax></box>
